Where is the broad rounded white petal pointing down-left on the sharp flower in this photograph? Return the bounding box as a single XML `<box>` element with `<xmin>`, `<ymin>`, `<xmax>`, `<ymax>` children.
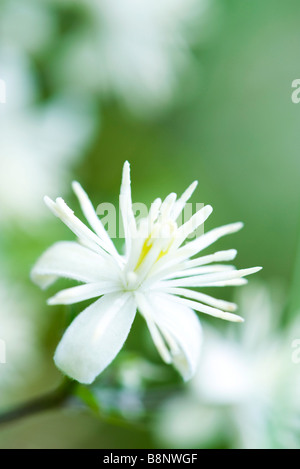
<box><xmin>54</xmin><ymin>293</ymin><xmax>136</xmax><ymax>384</ymax></box>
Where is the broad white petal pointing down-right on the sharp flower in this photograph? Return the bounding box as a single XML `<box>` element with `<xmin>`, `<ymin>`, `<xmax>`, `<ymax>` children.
<box><xmin>140</xmin><ymin>292</ymin><xmax>202</xmax><ymax>380</ymax></box>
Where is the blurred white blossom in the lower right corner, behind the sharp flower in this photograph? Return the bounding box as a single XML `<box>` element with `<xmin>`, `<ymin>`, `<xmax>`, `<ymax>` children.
<box><xmin>156</xmin><ymin>284</ymin><xmax>300</xmax><ymax>449</ymax></box>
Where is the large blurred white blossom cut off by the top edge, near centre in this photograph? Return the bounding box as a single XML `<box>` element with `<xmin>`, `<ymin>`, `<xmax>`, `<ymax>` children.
<box><xmin>57</xmin><ymin>0</ymin><xmax>209</xmax><ymax>113</ymax></box>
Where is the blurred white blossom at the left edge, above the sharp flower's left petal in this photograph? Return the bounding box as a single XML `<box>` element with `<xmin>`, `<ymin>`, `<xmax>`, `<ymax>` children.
<box><xmin>0</xmin><ymin>49</ymin><xmax>94</xmax><ymax>223</ymax></box>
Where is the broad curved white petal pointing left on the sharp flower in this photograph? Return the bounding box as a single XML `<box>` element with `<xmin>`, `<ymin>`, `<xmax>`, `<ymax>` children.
<box><xmin>31</xmin><ymin>241</ymin><xmax>119</xmax><ymax>288</ymax></box>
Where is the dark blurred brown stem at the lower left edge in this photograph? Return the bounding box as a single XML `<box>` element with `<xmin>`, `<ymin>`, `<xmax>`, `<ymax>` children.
<box><xmin>0</xmin><ymin>379</ymin><xmax>77</xmax><ymax>424</ymax></box>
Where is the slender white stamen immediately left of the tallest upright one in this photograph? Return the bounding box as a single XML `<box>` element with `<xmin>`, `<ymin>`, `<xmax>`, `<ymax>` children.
<box><xmin>72</xmin><ymin>181</ymin><xmax>119</xmax><ymax>258</ymax></box>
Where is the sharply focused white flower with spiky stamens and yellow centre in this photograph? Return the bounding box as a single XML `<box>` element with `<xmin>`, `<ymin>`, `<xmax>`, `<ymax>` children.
<box><xmin>32</xmin><ymin>162</ymin><xmax>260</xmax><ymax>383</ymax></box>
